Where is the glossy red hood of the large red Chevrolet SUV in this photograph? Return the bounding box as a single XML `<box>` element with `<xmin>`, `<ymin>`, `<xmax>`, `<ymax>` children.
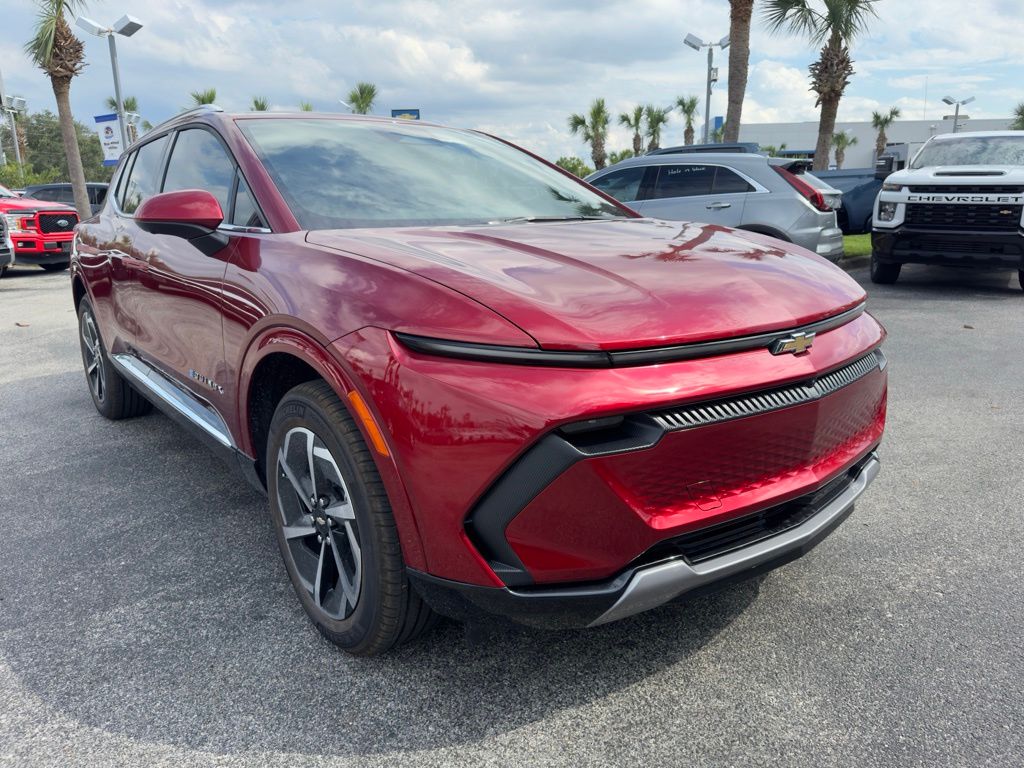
<box><xmin>307</xmin><ymin>219</ymin><xmax>864</xmax><ymax>350</ymax></box>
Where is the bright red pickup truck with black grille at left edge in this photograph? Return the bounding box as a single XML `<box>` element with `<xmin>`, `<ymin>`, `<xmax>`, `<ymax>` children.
<box><xmin>0</xmin><ymin>186</ymin><xmax>78</xmax><ymax>271</ymax></box>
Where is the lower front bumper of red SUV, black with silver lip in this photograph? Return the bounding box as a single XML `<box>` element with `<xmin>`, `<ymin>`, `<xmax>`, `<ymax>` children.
<box><xmin>410</xmin><ymin>453</ymin><xmax>881</xmax><ymax>629</ymax></box>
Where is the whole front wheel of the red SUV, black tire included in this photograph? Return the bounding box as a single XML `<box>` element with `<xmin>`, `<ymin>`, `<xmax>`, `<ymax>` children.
<box><xmin>266</xmin><ymin>381</ymin><xmax>436</xmax><ymax>656</ymax></box>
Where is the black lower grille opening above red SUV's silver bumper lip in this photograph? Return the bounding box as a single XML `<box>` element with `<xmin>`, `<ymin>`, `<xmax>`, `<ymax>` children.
<box><xmin>644</xmin><ymin>459</ymin><xmax>867</xmax><ymax>563</ymax></box>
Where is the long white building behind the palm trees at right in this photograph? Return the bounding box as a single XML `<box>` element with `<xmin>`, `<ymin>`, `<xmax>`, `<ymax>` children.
<box><xmin>739</xmin><ymin>115</ymin><xmax>1012</xmax><ymax>168</ymax></box>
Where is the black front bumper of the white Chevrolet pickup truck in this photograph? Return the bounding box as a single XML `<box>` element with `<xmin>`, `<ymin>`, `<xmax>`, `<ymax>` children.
<box><xmin>871</xmin><ymin>227</ymin><xmax>1024</xmax><ymax>269</ymax></box>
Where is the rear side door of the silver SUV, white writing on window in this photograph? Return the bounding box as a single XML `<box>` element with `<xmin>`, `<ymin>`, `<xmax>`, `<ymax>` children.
<box><xmin>636</xmin><ymin>163</ymin><xmax>754</xmax><ymax>226</ymax></box>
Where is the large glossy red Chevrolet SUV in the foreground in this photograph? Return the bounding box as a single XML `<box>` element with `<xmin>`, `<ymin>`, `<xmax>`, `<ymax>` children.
<box><xmin>72</xmin><ymin>109</ymin><xmax>887</xmax><ymax>654</ymax></box>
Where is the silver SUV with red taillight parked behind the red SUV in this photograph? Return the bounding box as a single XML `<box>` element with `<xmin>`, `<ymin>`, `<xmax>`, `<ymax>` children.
<box><xmin>586</xmin><ymin>153</ymin><xmax>843</xmax><ymax>261</ymax></box>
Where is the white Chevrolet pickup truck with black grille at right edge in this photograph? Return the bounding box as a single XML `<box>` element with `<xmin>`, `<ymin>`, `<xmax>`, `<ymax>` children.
<box><xmin>871</xmin><ymin>131</ymin><xmax>1024</xmax><ymax>289</ymax></box>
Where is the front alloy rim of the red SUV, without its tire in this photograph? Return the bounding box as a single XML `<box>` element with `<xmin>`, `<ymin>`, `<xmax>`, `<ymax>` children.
<box><xmin>276</xmin><ymin>427</ymin><xmax>362</xmax><ymax>621</ymax></box>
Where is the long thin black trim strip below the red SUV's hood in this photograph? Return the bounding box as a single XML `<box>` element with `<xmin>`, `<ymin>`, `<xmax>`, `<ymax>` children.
<box><xmin>394</xmin><ymin>304</ymin><xmax>864</xmax><ymax>368</ymax></box>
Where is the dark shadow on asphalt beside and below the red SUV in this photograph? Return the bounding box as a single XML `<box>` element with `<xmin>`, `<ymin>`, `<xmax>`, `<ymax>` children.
<box><xmin>0</xmin><ymin>372</ymin><xmax>759</xmax><ymax>756</ymax></box>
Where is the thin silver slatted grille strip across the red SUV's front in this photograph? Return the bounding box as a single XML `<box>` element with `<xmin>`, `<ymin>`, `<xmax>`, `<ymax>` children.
<box><xmin>652</xmin><ymin>352</ymin><xmax>881</xmax><ymax>431</ymax></box>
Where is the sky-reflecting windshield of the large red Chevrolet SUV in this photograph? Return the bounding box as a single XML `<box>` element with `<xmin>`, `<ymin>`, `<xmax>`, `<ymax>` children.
<box><xmin>239</xmin><ymin>118</ymin><xmax>629</xmax><ymax>229</ymax></box>
